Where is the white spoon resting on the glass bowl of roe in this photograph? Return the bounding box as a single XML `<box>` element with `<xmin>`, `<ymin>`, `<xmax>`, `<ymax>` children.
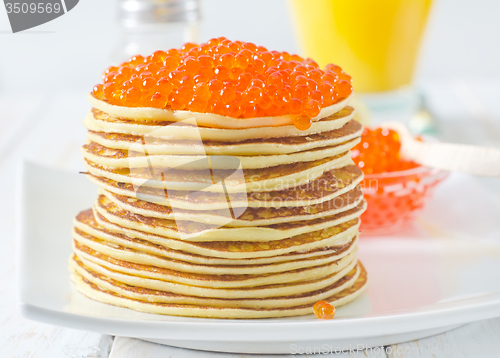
<box><xmin>382</xmin><ymin>122</ymin><xmax>500</xmax><ymax>177</ymax></box>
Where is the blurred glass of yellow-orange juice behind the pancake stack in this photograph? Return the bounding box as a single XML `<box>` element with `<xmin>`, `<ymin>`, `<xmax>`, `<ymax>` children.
<box><xmin>291</xmin><ymin>0</ymin><xmax>432</xmax><ymax>123</ymax></box>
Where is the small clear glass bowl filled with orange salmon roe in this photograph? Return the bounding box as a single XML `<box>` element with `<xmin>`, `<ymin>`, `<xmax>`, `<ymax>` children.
<box><xmin>352</xmin><ymin>128</ymin><xmax>448</xmax><ymax>235</ymax></box>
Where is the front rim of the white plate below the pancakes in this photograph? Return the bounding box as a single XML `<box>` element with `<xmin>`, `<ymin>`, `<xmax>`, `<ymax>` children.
<box><xmin>19</xmin><ymin>292</ymin><xmax>500</xmax><ymax>342</ymax></box>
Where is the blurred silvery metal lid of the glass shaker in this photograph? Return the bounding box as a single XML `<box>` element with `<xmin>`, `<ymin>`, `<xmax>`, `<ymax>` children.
<box><xmin>118</xmin><ymin>0</ymin><xmax>200</xmax><ymax>27</ymax></box>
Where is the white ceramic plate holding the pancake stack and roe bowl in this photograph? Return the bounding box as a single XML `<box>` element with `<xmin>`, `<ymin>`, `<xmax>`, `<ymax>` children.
<box><xmin>18</xmin><ymin>164</ymin><xmax>500</xmax><ymax>353</ymax></box>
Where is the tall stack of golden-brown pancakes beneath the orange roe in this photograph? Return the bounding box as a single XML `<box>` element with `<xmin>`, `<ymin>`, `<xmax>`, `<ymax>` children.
<box><xmin>70</xmin><ymin>101</ymin><xmax>367</xmax><ymax>318</ymax></box>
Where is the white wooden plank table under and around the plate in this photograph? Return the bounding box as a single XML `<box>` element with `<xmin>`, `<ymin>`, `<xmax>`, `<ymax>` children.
<box><xmin>0</xmin><ymin>82</ymin><xmax>500</xmax><ymax>358</ymax></box>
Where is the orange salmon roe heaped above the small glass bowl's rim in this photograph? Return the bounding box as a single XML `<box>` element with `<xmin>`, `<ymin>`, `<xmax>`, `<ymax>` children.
<box><xmin>351</xmin><ymin>128</ymin><xmax>418</xmax><ymax>174</ymax></box>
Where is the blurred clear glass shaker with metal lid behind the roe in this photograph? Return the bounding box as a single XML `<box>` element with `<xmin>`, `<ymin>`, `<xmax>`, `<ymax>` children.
<box><xmin>112</xmin><ymin>0</ymin><xmax>200</xmax><ymax>63</ymax></box>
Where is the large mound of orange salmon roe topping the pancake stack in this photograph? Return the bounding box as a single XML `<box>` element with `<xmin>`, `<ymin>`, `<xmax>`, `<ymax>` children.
<box><xmin>92</xmin><ymin>37</ymin><xmax>352</xmax><ymax>129</ymax></box>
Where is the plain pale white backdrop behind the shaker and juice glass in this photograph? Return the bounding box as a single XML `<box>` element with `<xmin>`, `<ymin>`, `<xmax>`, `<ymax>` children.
<box><xmin>0</xmin><ymin>0</ymin><xmax>500</xmax><ymax>95</ymax></box>
